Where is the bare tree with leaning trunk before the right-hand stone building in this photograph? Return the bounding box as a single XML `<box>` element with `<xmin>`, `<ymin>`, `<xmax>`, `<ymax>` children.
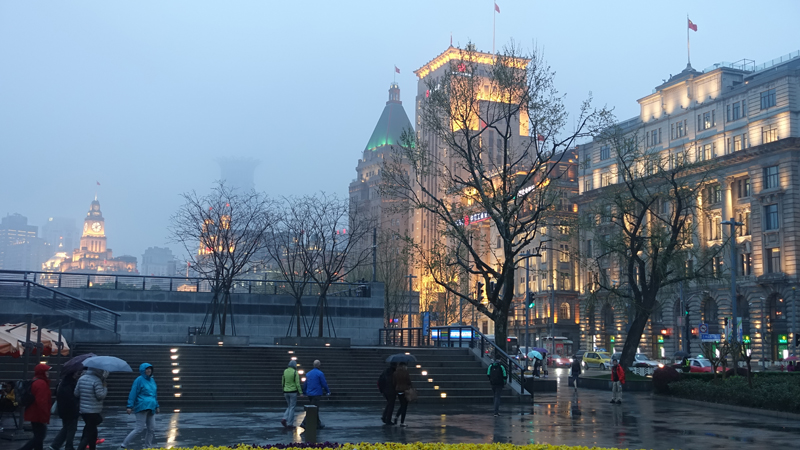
<box><xmin>578</xmin><ymin>126</ymin><xmax>722</xmax><ymax>367</ymax></box>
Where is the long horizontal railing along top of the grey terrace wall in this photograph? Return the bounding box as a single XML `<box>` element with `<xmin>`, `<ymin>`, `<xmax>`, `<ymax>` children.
<box><xmin>0</xmin><ymin>270</ymin><xmax>372</xmax><ymax>297</ymax></box>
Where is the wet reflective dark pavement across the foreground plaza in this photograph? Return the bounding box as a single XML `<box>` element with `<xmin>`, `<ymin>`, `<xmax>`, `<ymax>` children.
<box><xmin>0</xmin><ymin>370</ymin><xmax>800</xmax><ymax>450</ymax></box>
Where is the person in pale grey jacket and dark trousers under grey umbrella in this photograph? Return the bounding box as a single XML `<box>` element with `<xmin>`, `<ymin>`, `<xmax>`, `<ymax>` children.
<box><xmin>75</xmin><ymin>368</ymin><xmax>108</xmax><ymax>450</ymax></box>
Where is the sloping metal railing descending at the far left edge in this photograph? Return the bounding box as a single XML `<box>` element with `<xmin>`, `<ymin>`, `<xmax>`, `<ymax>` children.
<box><xmin>0</xmin><ymin>278</ymin><xmax>120</xmax><ymax>333</ymax></box>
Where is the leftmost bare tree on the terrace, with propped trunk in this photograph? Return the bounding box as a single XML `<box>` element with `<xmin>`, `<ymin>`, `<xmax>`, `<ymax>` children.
<box><xmin>170</xmin><ymin>181</ymin><xmax>273</xmax><ymax>335</ymax></box>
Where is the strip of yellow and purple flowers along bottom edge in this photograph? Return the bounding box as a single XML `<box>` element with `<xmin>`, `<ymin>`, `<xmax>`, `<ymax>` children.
<box><xmin>161</xmin><ymin>442</ymin><xmax>632</xmax><ymax>450</ymax></box>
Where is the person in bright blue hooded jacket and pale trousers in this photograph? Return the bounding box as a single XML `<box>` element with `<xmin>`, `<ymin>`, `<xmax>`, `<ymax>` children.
<box><xmin>120</xmin><ymin>363</ymin><xmax>160</xmax><ymax>448</ymax></box>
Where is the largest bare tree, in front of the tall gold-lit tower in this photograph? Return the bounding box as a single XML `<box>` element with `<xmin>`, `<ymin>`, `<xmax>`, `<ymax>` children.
<box><xmin>381</xmin><ymin>44</ymin><xmax>607</xmax><ymax>347</ymax></box>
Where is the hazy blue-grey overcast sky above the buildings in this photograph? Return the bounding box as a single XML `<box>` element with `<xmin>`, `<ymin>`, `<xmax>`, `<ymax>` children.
<box><xmin>0</xmin><ymin>0</ymin><xmax>800</xmax><ymax>258</ymax></box>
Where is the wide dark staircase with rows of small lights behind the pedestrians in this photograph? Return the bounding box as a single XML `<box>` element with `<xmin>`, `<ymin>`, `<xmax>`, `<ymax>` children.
<box><xmin>57</xmin><ymin>344</ymin><xmax>517</xmax><ymax>410</ymax></box>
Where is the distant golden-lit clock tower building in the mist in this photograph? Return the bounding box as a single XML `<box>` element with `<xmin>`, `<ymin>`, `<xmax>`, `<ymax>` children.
<box><xmin>52</xmin><ymin>198</ymin><xmax>138</xmax><ymax>274</ymax></box>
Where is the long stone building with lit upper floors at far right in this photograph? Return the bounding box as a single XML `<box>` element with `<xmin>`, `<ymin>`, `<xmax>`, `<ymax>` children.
<box><xmin>575</xmin><ymin>52</ymin><xmax>800</xmax><ymax>361</ymax></box>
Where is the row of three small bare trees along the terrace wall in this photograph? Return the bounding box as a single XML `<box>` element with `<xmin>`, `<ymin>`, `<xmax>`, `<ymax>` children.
<box><xmin>170</xmin><ymin>182</ymin><xmax>375</xmax><ymax>337</ymax></box>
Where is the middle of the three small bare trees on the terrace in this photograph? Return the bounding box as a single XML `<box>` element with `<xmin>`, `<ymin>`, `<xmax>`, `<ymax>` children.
<box><xmin>266</xmin><ymin>198</ymin><xmax>314</xmax><ymax>337</ymax></box>
